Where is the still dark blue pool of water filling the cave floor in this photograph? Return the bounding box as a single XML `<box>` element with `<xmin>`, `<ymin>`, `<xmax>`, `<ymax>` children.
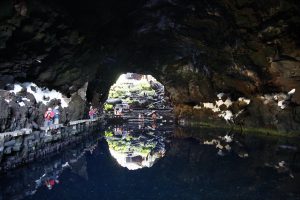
<box><xmin>0</xmin><ymin>125</ymin><xmax>300</xmax><ymax>200</ymax></box>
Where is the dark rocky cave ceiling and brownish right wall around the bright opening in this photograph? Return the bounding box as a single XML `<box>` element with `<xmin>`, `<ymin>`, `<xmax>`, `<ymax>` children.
<box><xmin>0</xmin><ymin>0</ymin><xmax>300</xmax><ymax>134</ymax></box>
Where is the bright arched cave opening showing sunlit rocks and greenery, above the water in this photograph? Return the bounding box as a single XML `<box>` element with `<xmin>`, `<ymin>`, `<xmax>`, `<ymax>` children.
<box><xmin>104</xmin><ymin>73</ymin><xmax>170</xmax><ymax>115</ymax></box>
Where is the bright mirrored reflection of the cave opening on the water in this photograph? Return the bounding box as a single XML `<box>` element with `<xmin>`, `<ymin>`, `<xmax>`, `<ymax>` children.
<box><xmin>105</xmin><ymin>122</ymin><xmax>172</xmax><ymax>170</ymax></box>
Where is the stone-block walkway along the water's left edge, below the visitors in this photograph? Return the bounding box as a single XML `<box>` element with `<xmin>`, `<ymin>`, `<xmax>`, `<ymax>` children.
<box><xmin>0</xmin><ymin>117</ymin><xmax>103</xmax><ymax>172</ymax></box>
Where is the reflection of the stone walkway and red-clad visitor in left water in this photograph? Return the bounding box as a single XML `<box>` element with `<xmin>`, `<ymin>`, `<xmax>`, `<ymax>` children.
<box><xmin>0</xmin><ymin>133</ymin><xmax>100</xmax><ymax>200</ymax></box>
